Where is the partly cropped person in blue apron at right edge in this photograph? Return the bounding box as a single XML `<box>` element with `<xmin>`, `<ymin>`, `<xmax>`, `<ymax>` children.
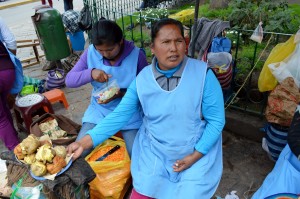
<box><xmin>252</xmin><ymin>105</ymin><xmax>300</xmax><ymax>199</ymax></box>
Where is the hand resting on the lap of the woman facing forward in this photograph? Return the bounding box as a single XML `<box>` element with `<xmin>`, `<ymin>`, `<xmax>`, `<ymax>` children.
<box><xmin>173</xmin><ymin>150</ymin><xmax>203</xmax><ymax>172</ymax></box>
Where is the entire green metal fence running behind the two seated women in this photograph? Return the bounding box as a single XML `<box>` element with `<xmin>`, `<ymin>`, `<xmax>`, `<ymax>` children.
<box><xmin>85</xmin><ymin>0</ymin><xmax>291</xmax><ymax>117</ymax></box>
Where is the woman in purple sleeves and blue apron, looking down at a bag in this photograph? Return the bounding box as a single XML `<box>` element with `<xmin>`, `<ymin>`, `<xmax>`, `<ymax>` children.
<box><xmin>66</xmin><ymin>19</ymin><xmax>148</xmax><ymax>156</ymax></box>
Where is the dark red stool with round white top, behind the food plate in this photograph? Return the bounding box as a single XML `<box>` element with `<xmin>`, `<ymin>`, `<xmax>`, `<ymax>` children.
<box><xmin>14</xmin><ymin>93</ymin><xmax>54</xmax><ymax>133</ymax></box>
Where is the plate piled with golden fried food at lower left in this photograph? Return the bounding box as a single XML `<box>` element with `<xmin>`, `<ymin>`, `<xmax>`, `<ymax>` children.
<box><xmin>14</xmin><ymin>134</ymin><xmax>72</xmax><ymax>180</ymax></box>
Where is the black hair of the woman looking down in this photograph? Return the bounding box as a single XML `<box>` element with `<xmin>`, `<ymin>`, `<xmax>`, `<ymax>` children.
<box><xmin>92</xmin><ymin>19</ymin><xmax>123</xmax><ymax>45</ymax></box>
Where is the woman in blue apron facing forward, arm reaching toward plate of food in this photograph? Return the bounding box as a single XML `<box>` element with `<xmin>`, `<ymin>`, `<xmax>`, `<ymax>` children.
<box><xmin>67</xmin><ymin>19</ymin><xmax>225</xmax><ymax>199</ymax></box>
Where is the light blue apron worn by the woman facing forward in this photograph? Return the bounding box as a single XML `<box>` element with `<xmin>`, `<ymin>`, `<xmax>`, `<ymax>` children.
<box><xmin>131</xmin><ymin>59</ymin><xmax>223</xmax><ymax>199</ymax></box>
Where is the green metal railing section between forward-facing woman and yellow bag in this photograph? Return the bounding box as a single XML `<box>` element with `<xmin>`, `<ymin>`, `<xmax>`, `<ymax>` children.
<box><xmin>227</xmin><ymin>30</ymin><xmax>291</xmax><ymax>117</ymax></box>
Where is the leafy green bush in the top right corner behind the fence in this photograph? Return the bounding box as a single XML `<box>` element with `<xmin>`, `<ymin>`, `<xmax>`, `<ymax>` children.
<box><xmin>228</xmin><ymin>0</ymin><xmax>299</xmax><ymax>33</ymax></box>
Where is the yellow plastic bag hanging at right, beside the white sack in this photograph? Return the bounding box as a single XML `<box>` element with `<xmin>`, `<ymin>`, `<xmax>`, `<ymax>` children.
<box><xmin>258</xmin><ymin>35</ymin><xmax>296</xmax><ymax>92</ymax></box>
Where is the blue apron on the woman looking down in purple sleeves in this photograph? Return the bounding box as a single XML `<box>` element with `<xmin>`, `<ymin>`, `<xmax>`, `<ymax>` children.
<box><xmin>82</xmin><ymin>45</ymin><xmax>142</xmax><ymax>130</ymax></box>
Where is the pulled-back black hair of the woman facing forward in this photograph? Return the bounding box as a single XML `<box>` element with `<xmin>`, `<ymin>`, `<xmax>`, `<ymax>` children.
<box><xmin>151</xmin><ymin>18</ymin><xmax>184</xmax><ymax>43</ymax></box>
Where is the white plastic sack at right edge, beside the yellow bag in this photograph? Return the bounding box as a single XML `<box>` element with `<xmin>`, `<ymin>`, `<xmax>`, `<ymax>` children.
<box><xmin>268</xmin><ymin>43</ymin><xmax>300</xmax><ymax>88</ymax></box>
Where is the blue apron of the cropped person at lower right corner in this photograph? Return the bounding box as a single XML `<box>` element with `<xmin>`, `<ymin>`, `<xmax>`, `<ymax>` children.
<box><xmin>252</xmin><ymin>144</ymin><xmax>300</xmax><ymax>199</ymax></box>
